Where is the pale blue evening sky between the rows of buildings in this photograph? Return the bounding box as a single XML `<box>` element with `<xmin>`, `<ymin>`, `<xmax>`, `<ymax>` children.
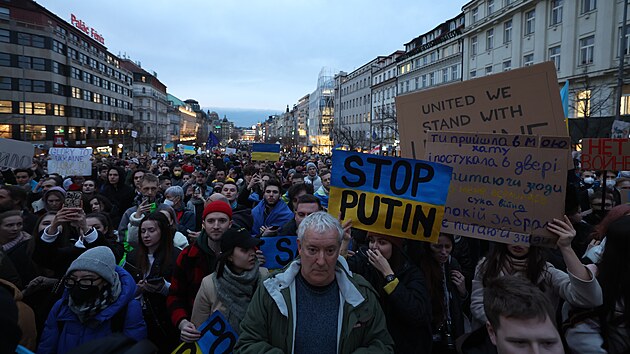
<box><xmin>37</xmin><ymin>0</ymin><xmax>467</xmax><ymax>125</ymax></box>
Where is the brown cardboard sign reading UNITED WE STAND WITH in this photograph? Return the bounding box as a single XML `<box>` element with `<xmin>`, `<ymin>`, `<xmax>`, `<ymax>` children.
<box><xmin>396</xmin><ymin>62</ymin><xmax>568</xmax><ymax>159</ymax></box>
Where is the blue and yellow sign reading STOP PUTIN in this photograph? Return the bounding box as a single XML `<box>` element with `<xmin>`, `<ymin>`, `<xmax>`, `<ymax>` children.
<box><xmin>328</xmin><ymin>150</ymin><xmax>452</xmax><ymax>242</ymax></box>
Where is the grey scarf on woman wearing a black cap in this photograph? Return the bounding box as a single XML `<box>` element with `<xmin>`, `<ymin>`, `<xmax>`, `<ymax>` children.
<box><xmin>213</xmin><ymin>260</ymin><xmax>260</xmax><ymax>332</ymax></box>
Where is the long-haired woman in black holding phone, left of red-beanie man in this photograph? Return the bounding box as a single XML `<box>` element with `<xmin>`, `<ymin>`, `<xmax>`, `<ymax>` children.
<box><xmin>124</xmin><ymin>211</ymin><xmax>179</xmax><ymax>353</ymax></box>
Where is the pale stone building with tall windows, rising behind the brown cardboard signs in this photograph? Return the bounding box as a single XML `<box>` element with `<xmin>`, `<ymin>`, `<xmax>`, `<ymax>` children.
<box><xmin>463</xmin><ymin>0</ymin><xmax>630</xmax><ymax>130</ymax></box>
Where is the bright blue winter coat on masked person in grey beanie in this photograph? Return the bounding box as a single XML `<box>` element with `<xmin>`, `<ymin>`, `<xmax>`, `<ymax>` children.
<box><xmin>37</xmin><ymin>266</ymin><xmax>147</xmax><ymax>354</ymax></box>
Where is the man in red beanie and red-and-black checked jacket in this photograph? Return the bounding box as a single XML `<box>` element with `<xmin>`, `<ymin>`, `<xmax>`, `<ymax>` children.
<box><xmin>166</xmin><ymin>201</ymin><xmax>232</xmax><ymax>342</ymax></box>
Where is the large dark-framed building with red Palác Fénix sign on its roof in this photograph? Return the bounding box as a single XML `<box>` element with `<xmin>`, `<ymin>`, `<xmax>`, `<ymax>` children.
<box><xmin>0</xmin><ymin>0</ymin><xmax>133</xmax><ymax>153</ymax></box>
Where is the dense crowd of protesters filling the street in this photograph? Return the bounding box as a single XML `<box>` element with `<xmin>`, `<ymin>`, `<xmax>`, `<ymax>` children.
<box><xmin>0</xmin><ymin>151</ymin><xmax>630</xmax><ymax>353</ymax></box>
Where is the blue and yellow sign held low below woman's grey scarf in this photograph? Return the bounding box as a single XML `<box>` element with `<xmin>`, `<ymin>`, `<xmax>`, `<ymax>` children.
<box><xmin>172</xmin><ymin>311</ymin><xmax>238</xmax><ymax>354</ymax></box>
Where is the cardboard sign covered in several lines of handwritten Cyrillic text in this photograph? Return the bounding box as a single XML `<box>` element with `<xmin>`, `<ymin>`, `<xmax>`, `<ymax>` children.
<box><xmin>426</xmin><ymin>132</ymin><xmax>570</xmax><ymax>246</ymax></box>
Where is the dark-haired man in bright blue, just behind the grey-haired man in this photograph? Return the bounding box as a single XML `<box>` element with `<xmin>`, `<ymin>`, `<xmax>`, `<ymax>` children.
<box><xmin>251</xmin><ymin>179</ymin><xmax>293</xmax><ymax>236</ymax></box>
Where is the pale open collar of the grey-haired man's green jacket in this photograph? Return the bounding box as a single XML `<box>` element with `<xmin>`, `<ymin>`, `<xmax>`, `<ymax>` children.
<box><xmin>263</xmin><ymin>256</ymin><xmax>365</xmax><ymax>317</ymax></box>
